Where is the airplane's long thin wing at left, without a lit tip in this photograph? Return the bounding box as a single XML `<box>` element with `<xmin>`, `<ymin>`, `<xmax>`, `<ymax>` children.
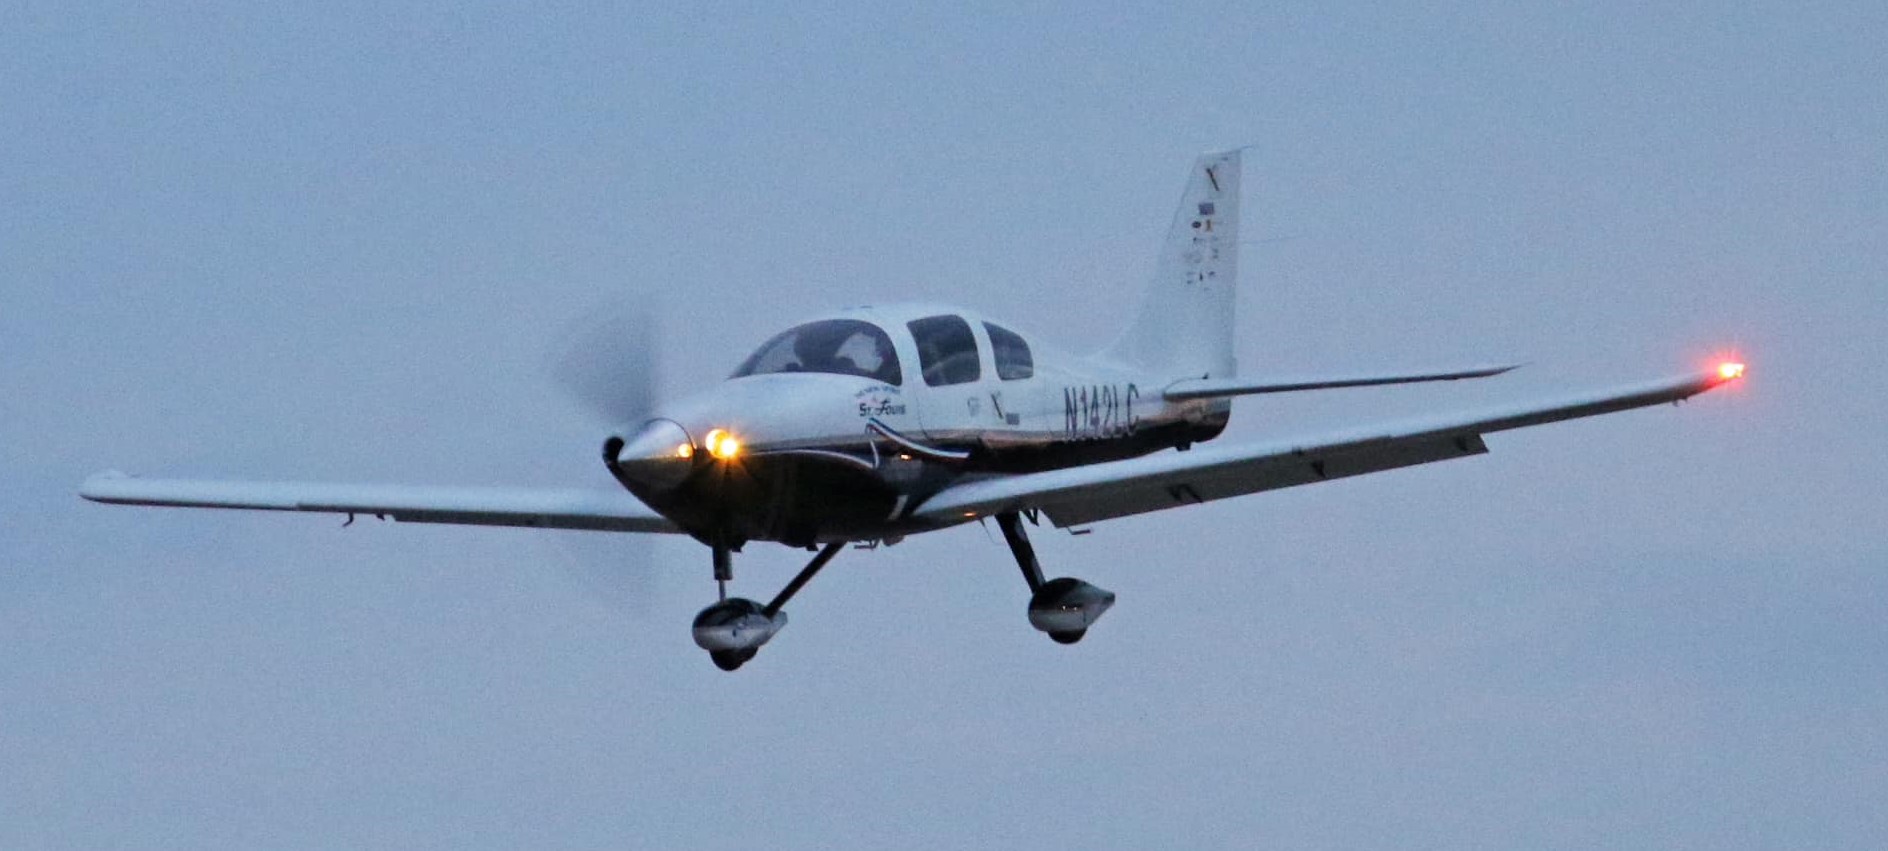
<box><xmin>79</xmin><ymin>472</ymin><xmax>680</xmax><ymax>532</ymax></box>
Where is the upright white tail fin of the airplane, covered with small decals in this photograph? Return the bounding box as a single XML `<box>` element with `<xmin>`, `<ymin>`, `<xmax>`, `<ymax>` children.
<box><xmin>1103</xmin><ymin>151</ymin><xmax>1240</xmax><ymax>377</ymax></box>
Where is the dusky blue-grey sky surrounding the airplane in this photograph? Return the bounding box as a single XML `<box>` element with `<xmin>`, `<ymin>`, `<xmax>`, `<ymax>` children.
<box><xmin>0</xmin><ymin>2</ymin><xmax>1888</xmax><ymax>849</ymax></box>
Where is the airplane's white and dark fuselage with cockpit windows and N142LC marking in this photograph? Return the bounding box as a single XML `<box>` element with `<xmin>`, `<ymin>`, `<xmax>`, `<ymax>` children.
<box><xmin>606</xmin><ymin>304</ymin><xmax>1229</xmax><ymax>545</ymax></box>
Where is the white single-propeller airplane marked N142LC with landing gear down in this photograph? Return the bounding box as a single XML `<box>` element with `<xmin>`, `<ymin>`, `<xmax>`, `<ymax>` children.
<box><xmin>79</xmin><ymin>151</ymin><xmax>1745</xmax><ymax>670</ymax></box>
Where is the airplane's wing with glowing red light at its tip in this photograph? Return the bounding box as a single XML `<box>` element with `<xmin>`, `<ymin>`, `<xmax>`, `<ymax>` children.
<box><xmin>912</xmin><ymin>364</ymin><xmax>1743</xmax><ymax>526</ymax></box>
